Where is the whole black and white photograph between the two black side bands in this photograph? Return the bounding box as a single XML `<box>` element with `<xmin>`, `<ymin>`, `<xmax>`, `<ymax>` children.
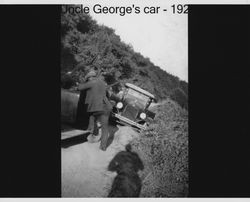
<box><xmin>61</xmin><ymin>1</ymin><xmax>188</xmax><ymax>197</ymax></box>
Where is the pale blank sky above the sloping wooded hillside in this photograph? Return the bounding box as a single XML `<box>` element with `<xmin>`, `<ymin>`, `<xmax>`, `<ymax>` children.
<box><xmin>85</xmin><ymin>0</ymin><xmax>188</xmax><ymax>81</ymax></box>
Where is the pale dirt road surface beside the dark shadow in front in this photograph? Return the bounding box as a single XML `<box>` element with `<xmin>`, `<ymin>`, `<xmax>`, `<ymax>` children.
<box><xmin>61</xmin><ymin>126</ymin><xmax>138</xmax><ymax>197</ymax></box>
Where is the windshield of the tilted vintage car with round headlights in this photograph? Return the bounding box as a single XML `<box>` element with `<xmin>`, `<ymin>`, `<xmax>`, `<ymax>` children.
<box><xmin>125</xmin><ymin>88</ymin><xmax>149</xmax><ymax>109</ymax></box>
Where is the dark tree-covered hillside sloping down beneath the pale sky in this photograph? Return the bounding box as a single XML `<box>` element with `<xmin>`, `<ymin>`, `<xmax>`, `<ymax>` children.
<box><xmin>61</xmin><ymin>5</ymin><xmax>188</xmax><ymax>109</ymax></box>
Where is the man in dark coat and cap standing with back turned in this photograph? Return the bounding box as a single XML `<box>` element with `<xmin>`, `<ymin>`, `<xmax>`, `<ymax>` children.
<box><xmin>78</xmin><ymin>71</ymin><xmax>112</xmax><ymax>151</ymax></box>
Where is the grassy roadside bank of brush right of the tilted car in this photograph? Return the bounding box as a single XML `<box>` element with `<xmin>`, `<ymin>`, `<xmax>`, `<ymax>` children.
<box><xmin>132</xmin><ymin>99</ymin><xmax>188</xmax><ymax>197</ymax></box>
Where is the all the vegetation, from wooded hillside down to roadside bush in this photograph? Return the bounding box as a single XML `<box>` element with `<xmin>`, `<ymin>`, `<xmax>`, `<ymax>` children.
<box><xmin>61</xmin><ymin>5</ymin><xmax>188</xmax><ymax>197</ymax></box>
